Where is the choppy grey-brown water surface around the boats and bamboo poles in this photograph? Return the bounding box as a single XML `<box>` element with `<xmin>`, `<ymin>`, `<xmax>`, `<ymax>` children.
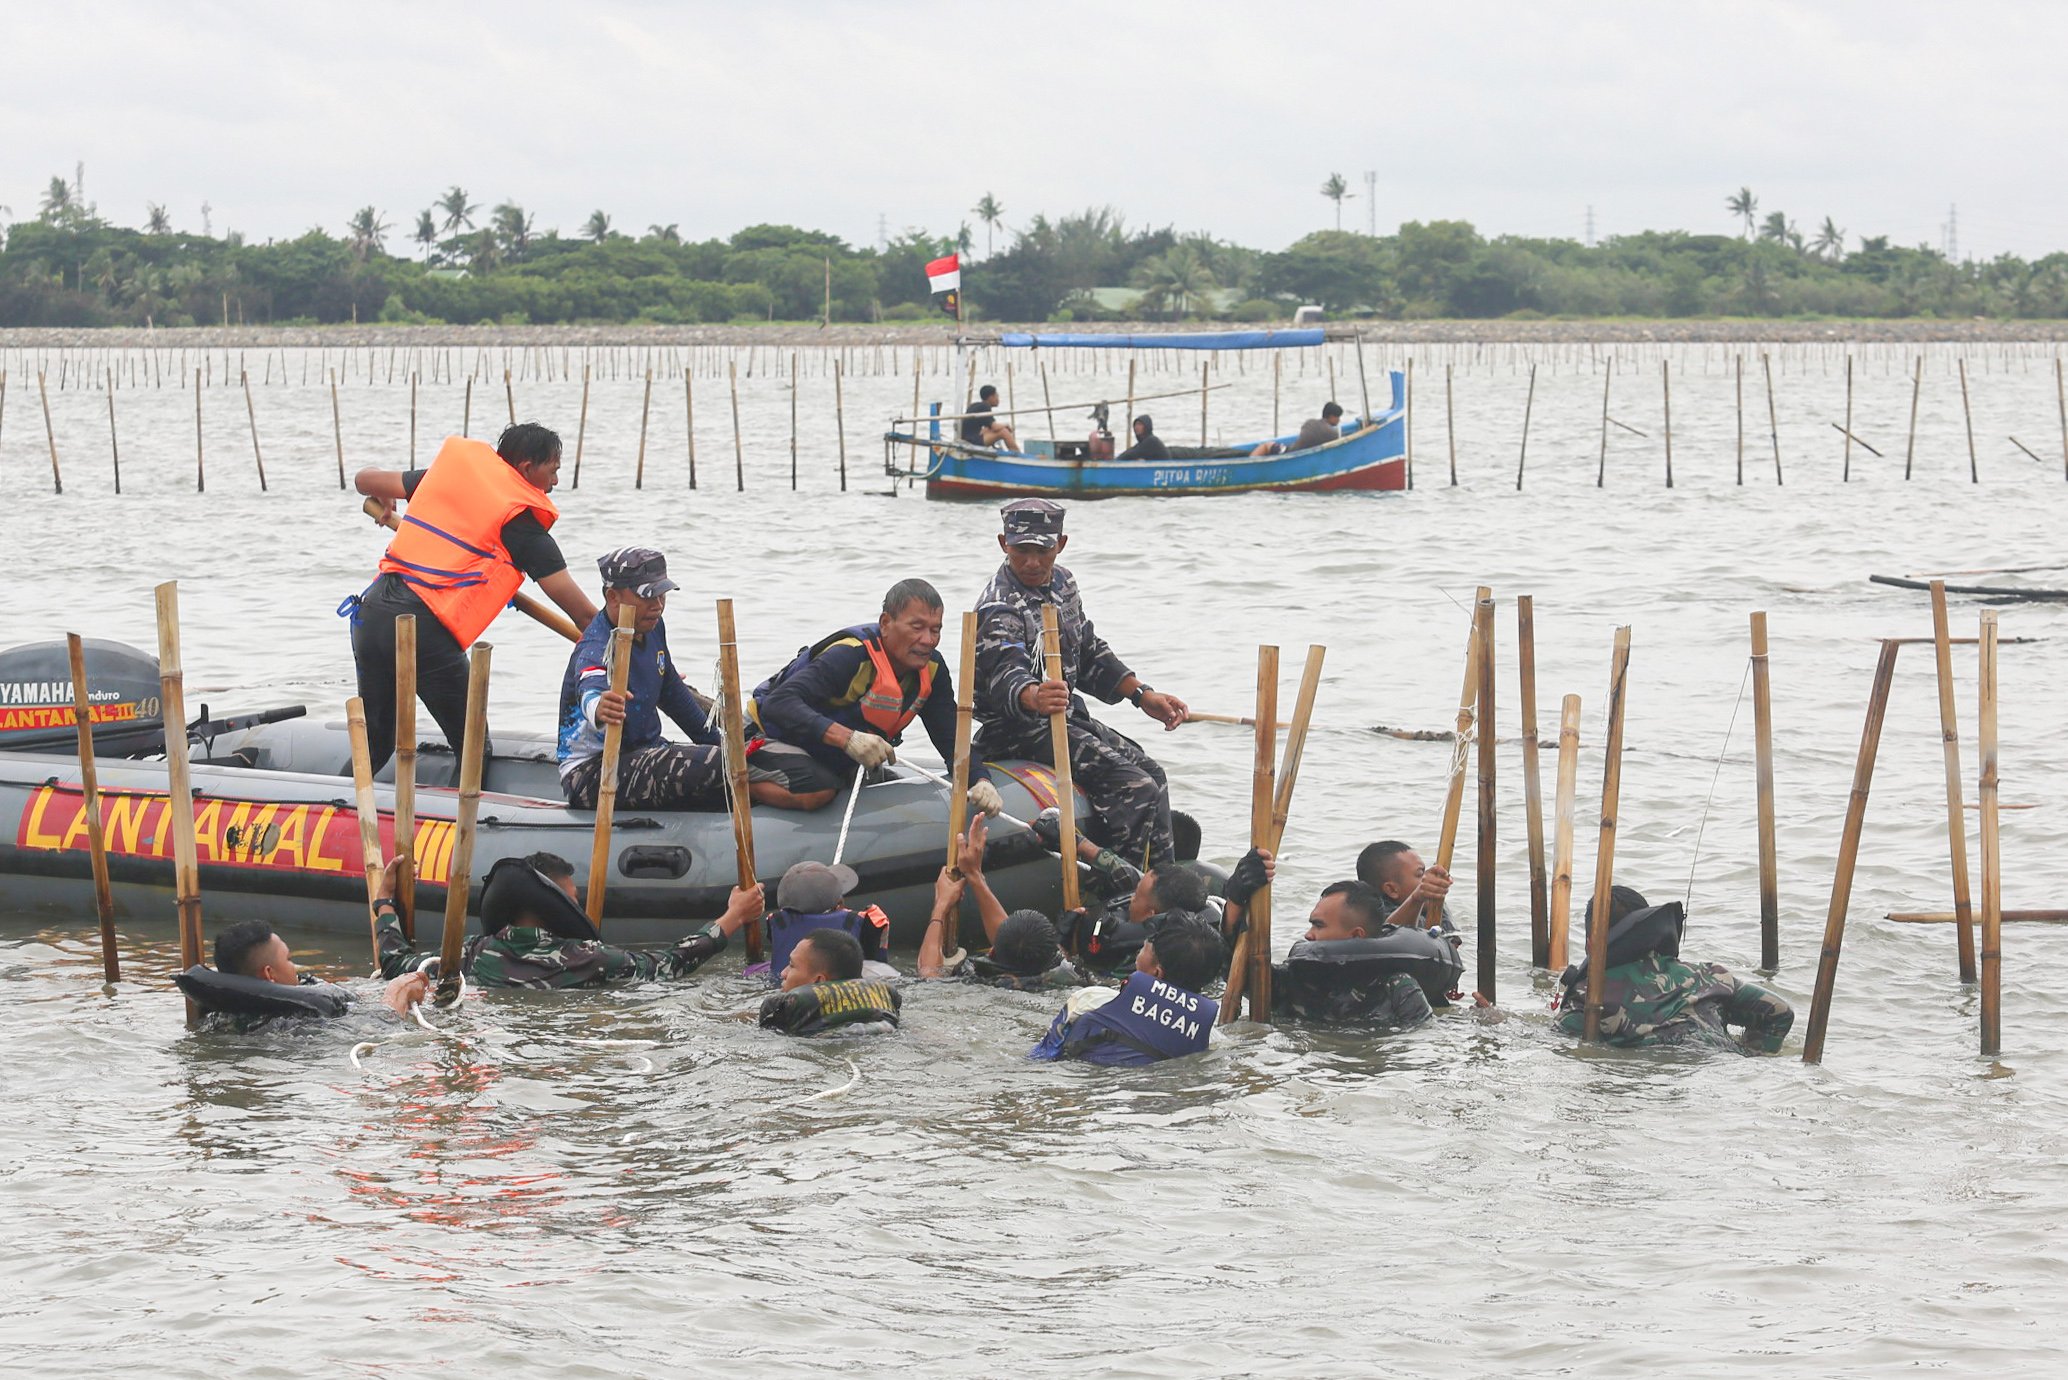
<box><xmin>0</xmin><ymin>350</ymin><xmax>2068</xmax><ymax>1376</ymax></box>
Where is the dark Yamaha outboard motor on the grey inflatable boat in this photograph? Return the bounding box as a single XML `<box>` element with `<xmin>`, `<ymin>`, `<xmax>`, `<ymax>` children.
<box><xmin>0</xmin><ymin>637</ymin><xmax>163</xmax><ymax>757</ymax></box>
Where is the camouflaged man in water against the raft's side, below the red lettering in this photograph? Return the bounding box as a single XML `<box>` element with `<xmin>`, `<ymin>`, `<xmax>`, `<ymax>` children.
<box><xmin>374</xmin><ymin>852</ymin><xmax>763</xmax><ymax>989</ymax></box>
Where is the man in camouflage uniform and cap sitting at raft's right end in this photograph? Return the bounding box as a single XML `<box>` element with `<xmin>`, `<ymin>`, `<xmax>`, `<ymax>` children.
<box><xmin>974</xmin><ymin>499</ymin><xmax>1189</xmax><ymax>867</ymax></box>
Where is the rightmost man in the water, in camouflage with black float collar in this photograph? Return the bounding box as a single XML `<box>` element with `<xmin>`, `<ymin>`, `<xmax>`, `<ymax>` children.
<box><xmin>1557</xmin><ymin>886</ymin><xmax>1795</xmax><ymax>1053</ymax></box>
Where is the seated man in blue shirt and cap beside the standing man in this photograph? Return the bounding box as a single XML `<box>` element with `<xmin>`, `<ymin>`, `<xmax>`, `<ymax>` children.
<box><xmin>558</xmin><ymin>546</ymin><xmax>823</xmax><ymax>809</ymax></box>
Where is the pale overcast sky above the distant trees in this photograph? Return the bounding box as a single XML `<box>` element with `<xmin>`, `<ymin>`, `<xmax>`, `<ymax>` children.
<box><xmin>0</xmin><ymin>0</ymin><xmax>2068</xmax><ymax>257</ymax></box>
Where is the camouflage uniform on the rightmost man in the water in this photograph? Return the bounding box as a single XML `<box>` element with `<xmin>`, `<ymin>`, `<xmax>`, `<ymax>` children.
<box><xmin>1557</xmin><ymin>954</ymin><xmax>1795</xmax><ymax>1053</ymax></box>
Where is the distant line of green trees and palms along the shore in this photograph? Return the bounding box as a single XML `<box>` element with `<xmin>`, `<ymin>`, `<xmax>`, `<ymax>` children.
<box><xmin>0</xmin><ymin>174</ymin><xmax>2068</xmax><ymax>327</ymax></box>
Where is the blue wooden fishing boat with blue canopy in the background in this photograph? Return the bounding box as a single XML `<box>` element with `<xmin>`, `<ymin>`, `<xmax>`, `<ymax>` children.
<box><xmin>883</xmin><ymin>329</ymin><xmax>1408</xmax><ymax>499</ymax></box>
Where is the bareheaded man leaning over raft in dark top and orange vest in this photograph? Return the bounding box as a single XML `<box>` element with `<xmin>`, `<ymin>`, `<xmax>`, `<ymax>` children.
<box><xmin>747</xmin><ymin>579</ymin><xmax>1005</xmax><ymax>815</ymax></box>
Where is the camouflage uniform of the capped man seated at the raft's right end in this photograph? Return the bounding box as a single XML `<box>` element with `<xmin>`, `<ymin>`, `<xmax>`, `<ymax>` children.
<box><xmin>974</xmin><ymin>565</ymin><xmax>1177</xmax><ymax>865</ymax></box>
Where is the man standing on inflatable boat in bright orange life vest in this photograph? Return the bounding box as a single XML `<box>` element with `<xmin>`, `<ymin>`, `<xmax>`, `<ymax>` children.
<box><xmin>351</xmin><ymin>422</ymin><xmax>596</xmax><ymax>772</ymax></box>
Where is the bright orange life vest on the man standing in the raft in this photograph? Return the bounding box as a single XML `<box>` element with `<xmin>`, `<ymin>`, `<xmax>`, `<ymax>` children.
<box><xmin>381</xmin><ymin>437</ymin><xmax>560</xmax><ymax>648</ymax></box>
